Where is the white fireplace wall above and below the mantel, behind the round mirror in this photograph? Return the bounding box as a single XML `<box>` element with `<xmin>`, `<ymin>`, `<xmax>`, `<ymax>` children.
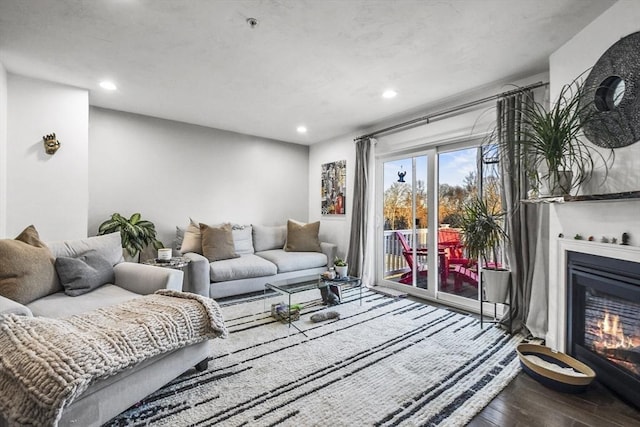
<box><xmin>546</xmin><ymin>0</ymin><xmax>640</xmax><ymax>348</ymax></box>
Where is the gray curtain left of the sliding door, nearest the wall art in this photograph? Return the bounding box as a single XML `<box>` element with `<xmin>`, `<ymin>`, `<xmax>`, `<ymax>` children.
<box><xmin>347</xmin><ymin>138</ymin><xmax>373</xmax><ymax>277</ymax></box>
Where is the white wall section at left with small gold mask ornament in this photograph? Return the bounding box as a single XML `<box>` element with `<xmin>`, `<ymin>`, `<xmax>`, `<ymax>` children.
<box><xmin>5</xmin><ymin>73</ymin><xmax>89</xmax><ymax>241</ymax></box>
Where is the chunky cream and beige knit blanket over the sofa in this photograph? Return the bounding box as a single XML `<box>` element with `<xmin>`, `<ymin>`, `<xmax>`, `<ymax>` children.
<box><xmin>0</xmin><ymin>290</ymin><xmax>227</xmax><ymax>426</ymax></box>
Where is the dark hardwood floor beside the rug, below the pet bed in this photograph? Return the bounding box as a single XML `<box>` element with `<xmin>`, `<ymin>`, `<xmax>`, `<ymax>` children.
<box><xmin>468</xmin><ymin>372</ymin><xmax>640</xmax><ymax>427</ymax></box>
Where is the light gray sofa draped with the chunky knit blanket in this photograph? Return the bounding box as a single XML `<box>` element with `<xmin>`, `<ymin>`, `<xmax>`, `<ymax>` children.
<box><xmin>0</xmin><ymin>233</ymin><xmax>209</xmax><ymax>426</ymax></box>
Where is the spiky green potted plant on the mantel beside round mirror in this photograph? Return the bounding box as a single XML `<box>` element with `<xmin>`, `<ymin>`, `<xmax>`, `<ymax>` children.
<box><xmin>499</xmin><ymin>79</ymin><xmax>614</xmax><ymax>196</ymax></box>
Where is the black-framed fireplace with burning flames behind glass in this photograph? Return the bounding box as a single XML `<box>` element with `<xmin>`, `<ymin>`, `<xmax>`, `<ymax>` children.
<box><xmin>566</xmin><ymin>252</ymin><xmax>640</xmax><ymax>406</ymax></box>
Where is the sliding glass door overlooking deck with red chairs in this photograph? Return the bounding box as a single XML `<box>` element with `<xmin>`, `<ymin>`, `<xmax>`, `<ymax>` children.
<box><xmin>378</xmin><ymin>141</ymin><xmax>501</xmax><ymax>310</ymax></box>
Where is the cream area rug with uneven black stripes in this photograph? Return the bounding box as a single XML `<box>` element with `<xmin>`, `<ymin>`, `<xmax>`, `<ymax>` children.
<box><xmin>110</xmin><ymin>289</ymin><xmax>521</xmax><ymax>426</ymax></box>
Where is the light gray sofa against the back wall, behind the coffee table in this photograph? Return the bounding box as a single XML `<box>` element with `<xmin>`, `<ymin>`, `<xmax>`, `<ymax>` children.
<box><xmin>177</xmin><ymin>221</ymin><xmax>337</xmax><ymax>299</ymax></box>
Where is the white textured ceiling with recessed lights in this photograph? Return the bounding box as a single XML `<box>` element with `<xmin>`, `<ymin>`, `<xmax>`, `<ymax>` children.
<box><xmin>0</xmin><ymin>0</ymin><xmax>614</xmax><ymax>144</ymax></box>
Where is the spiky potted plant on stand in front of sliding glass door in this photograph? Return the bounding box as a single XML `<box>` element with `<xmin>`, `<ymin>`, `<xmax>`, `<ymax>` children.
<box><xmin>461</xmin><ymin>195</ymin><xmax>511</xmax><ymax>303</ymax></box>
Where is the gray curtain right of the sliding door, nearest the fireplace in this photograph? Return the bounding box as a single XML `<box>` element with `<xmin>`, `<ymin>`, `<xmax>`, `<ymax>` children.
<box><xmin>496</xmin><ymin>91</ymin><xmax>539</xmax><ymax>335</ymax></box>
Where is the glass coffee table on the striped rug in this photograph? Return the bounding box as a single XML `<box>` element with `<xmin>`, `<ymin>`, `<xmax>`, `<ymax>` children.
<box><xmin>264</xmin><ymin>274</ymin><xmax>362</xmax><ymax>334</ymax></box>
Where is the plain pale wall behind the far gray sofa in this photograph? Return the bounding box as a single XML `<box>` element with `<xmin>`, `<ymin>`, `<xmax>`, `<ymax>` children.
<box><xmin>88</xmin><ymin>107</ymin><xmax>310</xmax><ymax>245</ymax></box>
